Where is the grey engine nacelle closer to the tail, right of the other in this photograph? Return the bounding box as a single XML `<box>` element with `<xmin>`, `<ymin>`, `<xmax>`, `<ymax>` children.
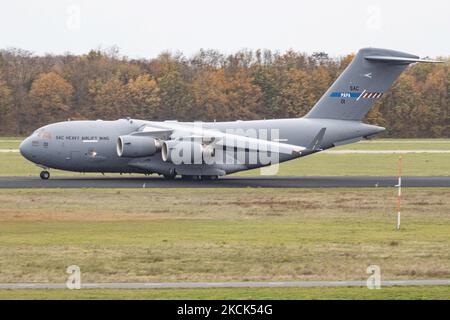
<box><xmin>161</xmin><ymin>140</ymin><xmax>214</xmax><ymax>165</ymax></box>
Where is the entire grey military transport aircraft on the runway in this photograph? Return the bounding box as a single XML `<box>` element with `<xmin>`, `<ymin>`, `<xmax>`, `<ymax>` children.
<box><xmin>20</xmin><ymin>48</ymin><xmax>438</xmax><ymax>179</ymax></box>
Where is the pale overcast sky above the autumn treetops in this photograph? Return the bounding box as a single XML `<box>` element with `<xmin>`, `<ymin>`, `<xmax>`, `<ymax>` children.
<box><xmin>0</xmin><ymin>0</ymin><xmax>450</xmax><ymax>58</ymax></box>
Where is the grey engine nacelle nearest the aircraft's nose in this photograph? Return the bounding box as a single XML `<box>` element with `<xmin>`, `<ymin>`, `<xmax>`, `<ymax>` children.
<box><xmin>117</xmin><ymin>135</ymin><xmax>161</xmax><ymax>158</ymax></box>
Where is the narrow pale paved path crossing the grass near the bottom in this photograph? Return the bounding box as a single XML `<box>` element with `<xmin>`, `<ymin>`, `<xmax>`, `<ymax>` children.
<box><xmin>0</xmin><ymin>279</ymin><xmax>450</xmax><ymax>289</ymax></box>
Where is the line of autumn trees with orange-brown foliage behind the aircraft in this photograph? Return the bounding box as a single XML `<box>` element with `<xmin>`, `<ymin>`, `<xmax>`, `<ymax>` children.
<box><xmin>0</xmin><ymin>48</ymin><xmax>450</xmax><ymax>138</ymax></box>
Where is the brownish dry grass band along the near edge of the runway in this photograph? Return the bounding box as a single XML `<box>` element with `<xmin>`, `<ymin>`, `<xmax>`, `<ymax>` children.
<box><xmin>0</xmin><ymin>188</ymin><xmax>450</xmax><ymax>222</ymax></box>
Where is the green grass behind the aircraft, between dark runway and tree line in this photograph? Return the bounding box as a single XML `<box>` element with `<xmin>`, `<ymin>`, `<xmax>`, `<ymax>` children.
<box><xmin>0</xmin><ymin>138</ymin><xmax>450</xmax><ymax>176</ymax></box>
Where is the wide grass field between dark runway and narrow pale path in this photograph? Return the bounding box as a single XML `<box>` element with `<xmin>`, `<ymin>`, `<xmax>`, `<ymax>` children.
<box><xmin>0</xmin><ymin>189</ymin><xmax>450</xmax><ymax>282</ymax></box>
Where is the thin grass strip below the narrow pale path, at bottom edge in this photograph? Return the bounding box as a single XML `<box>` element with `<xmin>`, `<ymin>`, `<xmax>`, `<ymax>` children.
<box><xmin>0</xmin><ymin>286</ymin><xmax>450</xmax><ymax>300</ymax></box>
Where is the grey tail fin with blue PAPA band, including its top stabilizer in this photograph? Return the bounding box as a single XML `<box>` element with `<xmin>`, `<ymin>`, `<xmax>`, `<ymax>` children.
<box><xmin>305</xmin><ymin>48</ymin><xmax>438</xmax><ymax>121</ymax></box>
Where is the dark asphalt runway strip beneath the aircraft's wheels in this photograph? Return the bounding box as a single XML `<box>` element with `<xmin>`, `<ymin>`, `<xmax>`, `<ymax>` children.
<box><xmin>0</xmin><ymin>176</ymin><xmax>450</xmax><ymax>189</ymax></box>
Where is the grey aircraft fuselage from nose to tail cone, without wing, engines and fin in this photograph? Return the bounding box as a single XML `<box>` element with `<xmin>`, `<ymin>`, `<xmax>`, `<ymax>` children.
<box><xmin>20</xmin><ymin>118</ymin><xmax>384</xmax><ymax>175</ymax></box>
